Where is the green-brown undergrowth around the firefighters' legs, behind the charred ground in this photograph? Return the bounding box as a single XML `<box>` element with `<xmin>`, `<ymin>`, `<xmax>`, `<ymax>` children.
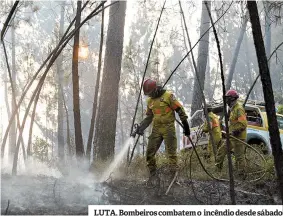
<box><xmin>92</xmin><ymin>143</ymin><xmax>275</xmax><ymax>182</ymax></box>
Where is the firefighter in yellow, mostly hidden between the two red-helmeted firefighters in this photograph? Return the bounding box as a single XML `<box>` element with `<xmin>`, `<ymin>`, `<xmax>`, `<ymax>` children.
<box><xmin>202</xmin><ymin>105</ymin><xmax>222</xmax><ymax>158</ymax></box>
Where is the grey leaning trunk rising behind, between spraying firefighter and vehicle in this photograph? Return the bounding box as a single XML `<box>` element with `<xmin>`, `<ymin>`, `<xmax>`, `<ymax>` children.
<box><xmin>191</xmin><ymin>1</ymin><xmax>211</xmax><ymax>119</ymax></box>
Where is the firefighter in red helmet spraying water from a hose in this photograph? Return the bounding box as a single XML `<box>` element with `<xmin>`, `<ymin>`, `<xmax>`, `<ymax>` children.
<box><xmin>137</xmin><ymin>79</ymin><xmax>190</xmax><ymax>176</ymax></box>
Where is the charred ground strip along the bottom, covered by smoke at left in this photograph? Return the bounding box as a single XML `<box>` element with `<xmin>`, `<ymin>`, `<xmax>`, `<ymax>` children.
<box><xmin>1</xmin><ymin>174</ymin><xmax>276</xmax><ymax>215</ymax></box>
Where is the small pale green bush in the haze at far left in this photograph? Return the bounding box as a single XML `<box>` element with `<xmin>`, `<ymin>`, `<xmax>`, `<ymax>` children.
<box><xmin>33</xmin><ymin>137</ymin><xmax>50</xmax><ymax>162</ymax></box>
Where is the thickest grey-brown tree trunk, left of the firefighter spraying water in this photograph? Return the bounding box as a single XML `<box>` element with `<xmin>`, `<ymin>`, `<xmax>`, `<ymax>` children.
<box><xmin>94</xmin><ymin>1</ymin><xmax>126</xmax><ymax>160</ymax></box>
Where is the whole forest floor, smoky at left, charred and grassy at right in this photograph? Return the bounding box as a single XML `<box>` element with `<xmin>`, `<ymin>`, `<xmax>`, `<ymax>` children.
<box><xmin>1</xmin><ymin>149</ymin><xmax>280</xmax><ymax>215</ymax></box>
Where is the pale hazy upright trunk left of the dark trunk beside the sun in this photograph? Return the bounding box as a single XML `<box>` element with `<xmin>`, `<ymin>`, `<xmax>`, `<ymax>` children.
<box><xmin>56</xmin><ymin>1</ymin><xmax>65</xmax><ymax>164</ymax></box>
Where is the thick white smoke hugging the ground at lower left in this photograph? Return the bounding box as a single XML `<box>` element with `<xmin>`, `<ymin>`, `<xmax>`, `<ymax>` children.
<box><xmin>1</xmin><ymin>155</ymin><xmax>108</xmax><ymax>215</ymax></box>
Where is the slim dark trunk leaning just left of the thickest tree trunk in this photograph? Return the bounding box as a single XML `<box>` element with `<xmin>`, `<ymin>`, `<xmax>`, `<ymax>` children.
<box><xmin>86</xmin><ymin>7</ymin><xmax>104</xmax><ymax>161</ymax></box>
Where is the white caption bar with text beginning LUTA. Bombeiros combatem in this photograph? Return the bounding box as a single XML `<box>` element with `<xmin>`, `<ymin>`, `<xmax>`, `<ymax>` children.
<box><xmin>88</xmin><ymin>205</ymin><xmax>283</xmax><ymax>216</ymax></box>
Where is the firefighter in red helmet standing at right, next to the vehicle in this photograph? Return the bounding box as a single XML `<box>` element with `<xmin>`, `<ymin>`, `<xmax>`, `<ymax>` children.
<box><xmin>215</xmin><ymin>89</ymin><xmax>248</xmax><ymax>174</ymax></box>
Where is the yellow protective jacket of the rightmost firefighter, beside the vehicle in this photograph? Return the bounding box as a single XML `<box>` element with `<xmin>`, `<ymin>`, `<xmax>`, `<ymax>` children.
<box><xmin>229</xmin><ymin>102</ymin><xmax>248</xmax><ymax>140</ymax></box>
